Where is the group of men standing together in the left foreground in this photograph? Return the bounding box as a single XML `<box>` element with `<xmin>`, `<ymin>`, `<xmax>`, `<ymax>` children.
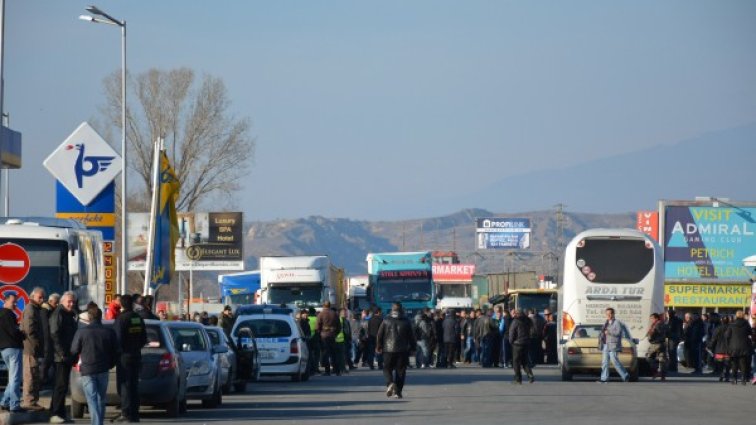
<box><xmin>0</xmin><ymin>287</ymin><xmax>158</xmax><ymax>425</ymax></box>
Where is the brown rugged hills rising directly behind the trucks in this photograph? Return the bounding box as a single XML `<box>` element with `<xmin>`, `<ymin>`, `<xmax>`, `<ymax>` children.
<box><xmin>245</xmin><ymin>209</ymin><xmax>635</xmax><ymax>274</ymax></box>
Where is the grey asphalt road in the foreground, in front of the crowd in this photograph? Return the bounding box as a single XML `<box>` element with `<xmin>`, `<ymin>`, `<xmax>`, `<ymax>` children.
<box><xmin>91</xmin><ymin>367</ymin><xmax>756</xmax><ymax>425</ymax></box>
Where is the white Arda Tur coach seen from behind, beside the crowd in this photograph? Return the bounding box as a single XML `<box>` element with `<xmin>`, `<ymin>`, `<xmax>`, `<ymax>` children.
<box><xmin>559</xmin><ymin>229</ymin><xmax>664</xmax><ymax>371</ymax></box>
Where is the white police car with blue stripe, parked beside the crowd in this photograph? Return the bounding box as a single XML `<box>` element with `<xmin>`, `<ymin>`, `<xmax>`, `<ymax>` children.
<box><xmin>231</xmin><ymin>305</ymin><xmax>310</xmax><ymax>381</ymax></box>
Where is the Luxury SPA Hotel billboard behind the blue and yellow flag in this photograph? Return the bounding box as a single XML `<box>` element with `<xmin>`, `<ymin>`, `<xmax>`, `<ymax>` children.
<box><xmin>128</xmin><ymin>212</ymin><xmax>244</xmax><ymax>271</ymax></box>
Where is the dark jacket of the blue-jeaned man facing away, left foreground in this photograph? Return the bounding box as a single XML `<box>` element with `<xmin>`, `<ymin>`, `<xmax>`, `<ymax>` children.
<box><xmin>71</xmin><ymin>322</ymin><xmax>118</xmax><ymax>375</ymax></box>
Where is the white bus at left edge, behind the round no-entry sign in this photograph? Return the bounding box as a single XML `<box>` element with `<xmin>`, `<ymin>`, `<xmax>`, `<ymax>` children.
<box><xmin>0</xmin><ymin>218</ymin><xmax>105</xmax><ymax>314</ymax></box>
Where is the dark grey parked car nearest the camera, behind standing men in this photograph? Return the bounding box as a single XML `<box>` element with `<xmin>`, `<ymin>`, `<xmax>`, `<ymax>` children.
<box><xmin>70</xmin><ymin>320</ymin><xmax>187</xmax><ymax>418</ymax></box>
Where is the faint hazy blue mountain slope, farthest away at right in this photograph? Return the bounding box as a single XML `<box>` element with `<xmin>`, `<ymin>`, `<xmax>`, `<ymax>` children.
<box><xmin>434</xmin><ymin>123</ymin><xmax>756</xmax><ymax>213</ymax></box>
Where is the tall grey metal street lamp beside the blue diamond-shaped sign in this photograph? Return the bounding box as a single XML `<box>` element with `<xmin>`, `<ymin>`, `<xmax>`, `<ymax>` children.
<box><xmin>79</xmin><ymin>6</ymin><xmax>128</xmax><ymax>294</ymax></box>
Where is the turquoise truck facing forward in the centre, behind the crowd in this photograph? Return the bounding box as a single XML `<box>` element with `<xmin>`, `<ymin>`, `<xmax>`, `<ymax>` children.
<box><xmin>366</xmin><ymin>251</ymin><xmax>436</xmax><ymax>317</ymax></box>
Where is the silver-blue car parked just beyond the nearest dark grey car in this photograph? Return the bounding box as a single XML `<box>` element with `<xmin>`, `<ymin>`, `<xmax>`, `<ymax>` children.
<box><xmin>163</xmin><ymin>322</ymin><xmax>228</xmax><ymax>407</ymax></box>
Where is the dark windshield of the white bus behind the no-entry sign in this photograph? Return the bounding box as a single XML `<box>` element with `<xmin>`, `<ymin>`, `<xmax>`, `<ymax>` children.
<box><xmin>0</xmin><ymin>239</ymin><xmax>68</xmax><ymax>295</ymax></box>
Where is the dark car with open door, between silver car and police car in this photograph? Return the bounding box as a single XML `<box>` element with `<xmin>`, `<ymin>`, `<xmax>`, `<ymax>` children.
<box><xmin>205</xmin><ymin>326</ymin><xmax>260</xmax><ymax>394</ymax></box>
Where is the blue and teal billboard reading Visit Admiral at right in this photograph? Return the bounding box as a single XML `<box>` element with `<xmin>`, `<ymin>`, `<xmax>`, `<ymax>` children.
<box><xmin>663</xmin><ymin>205</ymin><xmax>756</xmax><ymax>282</ymax></box>
